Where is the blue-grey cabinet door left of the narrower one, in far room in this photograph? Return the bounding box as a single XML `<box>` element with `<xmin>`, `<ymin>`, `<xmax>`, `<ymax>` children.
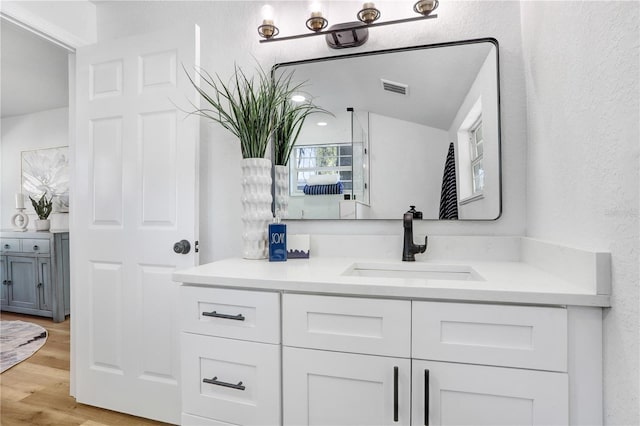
<box><xmin>7</xmin><ymin>256</ymin><xmax>38</xmax><ymax>310</ymax></box>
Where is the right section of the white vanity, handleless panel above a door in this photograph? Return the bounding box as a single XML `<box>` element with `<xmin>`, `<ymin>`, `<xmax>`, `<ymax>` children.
<box><xmin>412</xmin><ymin>301</ymin><xmax>569</xmax><ymax>426</ymax></box>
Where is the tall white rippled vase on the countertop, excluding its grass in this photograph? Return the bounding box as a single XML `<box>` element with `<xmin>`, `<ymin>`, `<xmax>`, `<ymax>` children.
<box><xmin>241</xmin><ymin>158</ymin><xmax>273</xmax><ymax>259</ymax></box>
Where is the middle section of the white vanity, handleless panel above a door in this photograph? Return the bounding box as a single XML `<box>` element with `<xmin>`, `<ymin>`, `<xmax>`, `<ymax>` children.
<box><xmin>282</xmin><ymin>294</ymin><xmax>411</xmax><ymax>426</ymax></box>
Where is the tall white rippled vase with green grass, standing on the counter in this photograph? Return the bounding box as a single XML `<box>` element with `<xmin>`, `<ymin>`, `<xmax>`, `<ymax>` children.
<box><xmin>185</xmin><ymin>61</ymin><xmax>316</xmax><ymax>259</ymax></box>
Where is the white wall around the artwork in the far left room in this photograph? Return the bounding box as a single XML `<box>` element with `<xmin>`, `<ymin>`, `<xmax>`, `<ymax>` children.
<box><xmin>0</xmin><ymin>108</ymin><xmax>69</xmax><ymax>230</ymax></box>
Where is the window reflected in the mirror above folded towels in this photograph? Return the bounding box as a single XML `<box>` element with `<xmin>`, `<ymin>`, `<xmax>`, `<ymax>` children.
<box><xmin>289</xmin><ymin>144</ymin><xmax>353</xmax><ymax>195</ymax></box>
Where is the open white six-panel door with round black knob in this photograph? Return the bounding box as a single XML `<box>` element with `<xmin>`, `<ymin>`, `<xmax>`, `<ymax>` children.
<box><xmin>71</xmin><ymin>27</ymin><xmax>199</xmax><ymax>423</ymax></box>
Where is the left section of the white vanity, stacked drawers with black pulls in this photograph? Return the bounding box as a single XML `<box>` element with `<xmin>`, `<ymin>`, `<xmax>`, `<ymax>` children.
<box><xmin>181</xmin><ymin>286</ymin><xmax>281</xmax><ymax>425</ymax></box>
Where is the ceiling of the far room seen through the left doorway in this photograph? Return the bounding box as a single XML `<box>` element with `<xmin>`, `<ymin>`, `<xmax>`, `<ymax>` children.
<box><xmin>0</xmin><ymin>19</ymin><xmax>69</xmax><ymax>118</ymax></box>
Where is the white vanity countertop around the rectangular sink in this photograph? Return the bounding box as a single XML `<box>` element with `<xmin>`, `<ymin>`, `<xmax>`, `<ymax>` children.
<box><xmin>173</xmin><ymin>257</ymin><xmax>610</xmax><ymax>307</ymax></box>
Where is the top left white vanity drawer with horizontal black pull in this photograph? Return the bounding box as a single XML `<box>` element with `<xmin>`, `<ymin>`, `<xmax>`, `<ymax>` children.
<box><xmin>180</xmin><ymin>285</ymin><xmax>280</xmax><ymax>343</ymax></box>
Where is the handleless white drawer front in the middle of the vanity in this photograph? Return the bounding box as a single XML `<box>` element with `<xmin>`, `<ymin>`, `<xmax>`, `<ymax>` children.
<box><xmin>282</xmin><ymin>294</ymin><xmax>411</xmax><ymax>358</ymax></box>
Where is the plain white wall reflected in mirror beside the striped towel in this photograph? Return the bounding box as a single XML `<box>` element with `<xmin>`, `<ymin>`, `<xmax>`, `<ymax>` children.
<box><xmin>368</xmin><ymin>113</ymin><xmax>449</xmax><ymax>219</ymax></box>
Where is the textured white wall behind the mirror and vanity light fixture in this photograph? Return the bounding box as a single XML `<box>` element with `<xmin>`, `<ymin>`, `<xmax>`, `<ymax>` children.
<box><xmin>92</xmin><ymin>0</ymin><xmax>526</xmax><ymax>262</ymax></box>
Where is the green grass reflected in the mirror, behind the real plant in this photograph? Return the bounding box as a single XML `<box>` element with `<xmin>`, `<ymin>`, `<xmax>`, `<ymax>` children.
<box><xmin>273</xmin><ymin>95</ymin><xmax>333</xmax><ymax>166</ymax></box>
